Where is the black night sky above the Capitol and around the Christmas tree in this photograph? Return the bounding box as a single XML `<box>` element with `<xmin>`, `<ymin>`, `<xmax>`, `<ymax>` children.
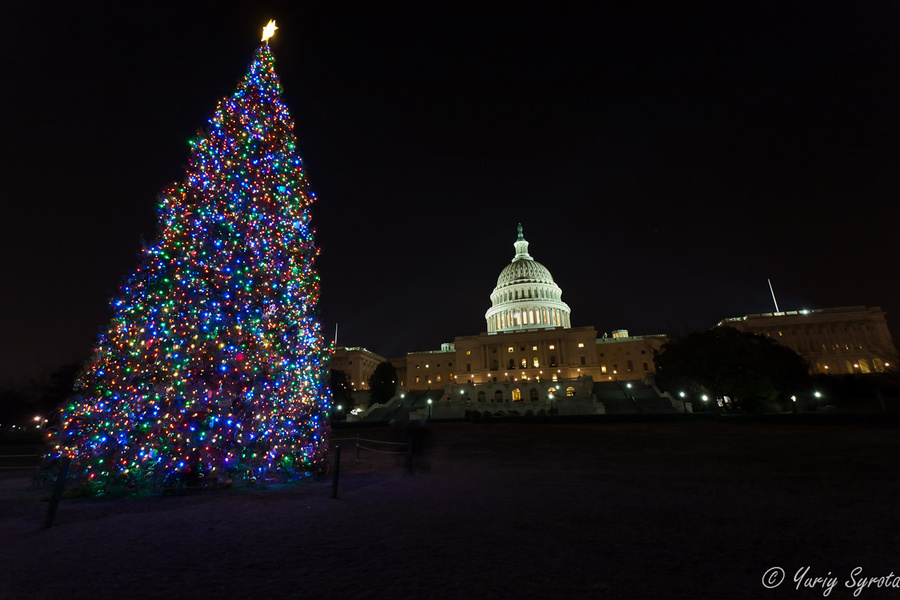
<box><xmin>0</xmin><ymin>0</ymin><xmax>900</xmax><ymax>380</ymax></box>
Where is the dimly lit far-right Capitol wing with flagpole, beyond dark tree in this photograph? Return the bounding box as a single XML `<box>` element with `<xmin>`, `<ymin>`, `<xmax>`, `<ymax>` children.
<box><xmin>717</xmin><ymin>306</ymin><xmax>898</xmax><ymax>374</ymax></box>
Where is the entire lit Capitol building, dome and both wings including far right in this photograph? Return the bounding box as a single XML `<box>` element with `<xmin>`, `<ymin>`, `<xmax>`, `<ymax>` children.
<box><xmin>332</xmin><ymin>224</ymin><xmax>900</xmax><ymax>418</ymax></box>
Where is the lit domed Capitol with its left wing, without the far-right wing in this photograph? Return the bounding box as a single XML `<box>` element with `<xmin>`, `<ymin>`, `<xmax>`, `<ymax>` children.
<box><xmin>331</xmin><ymin>225</ymin><xmax>685</xmax><ymax>417</ymax></box>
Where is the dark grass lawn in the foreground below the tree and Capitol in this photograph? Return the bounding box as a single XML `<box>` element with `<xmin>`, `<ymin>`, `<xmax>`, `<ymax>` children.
<box><xmin>0</xmin><ymin>417</ymin><xmax>900</xmax><ymax>599</ymax></box>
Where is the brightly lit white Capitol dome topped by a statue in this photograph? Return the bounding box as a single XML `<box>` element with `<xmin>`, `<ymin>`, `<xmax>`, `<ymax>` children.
<box><xmin>484</xmin><ymin>223</ymin><xmax>572</xmax><ymax>333</ymax></box>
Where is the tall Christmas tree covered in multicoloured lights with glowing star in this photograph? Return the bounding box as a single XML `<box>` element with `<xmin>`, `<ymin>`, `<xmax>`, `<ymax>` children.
<box><xmin>53</xmin><ymin>22</ymin><xmax>330</xmax><ymax>491</ymax></box>
